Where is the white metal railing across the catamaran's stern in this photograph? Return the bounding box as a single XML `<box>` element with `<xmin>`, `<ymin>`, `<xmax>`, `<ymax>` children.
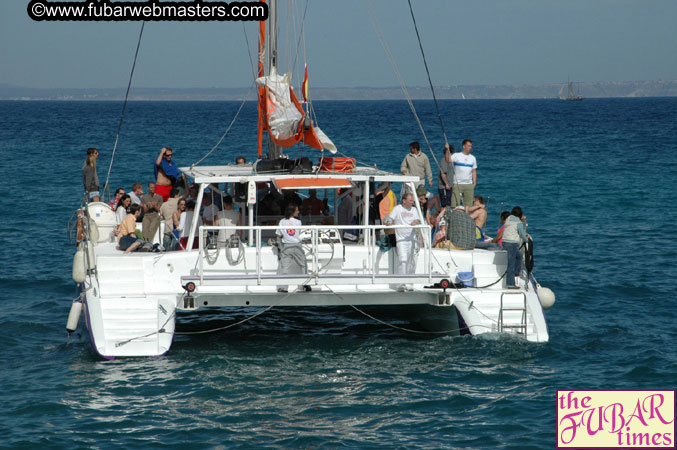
<box><xmin>191</xmin><ymin>224</ymin><xmax>433</xmax><ymax>284</ymax></box>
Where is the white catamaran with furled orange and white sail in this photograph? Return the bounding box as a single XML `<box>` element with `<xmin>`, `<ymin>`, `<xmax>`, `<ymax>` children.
<box><xmin>67</xmin><ymin>1</ymin><xmax>554</xmax><ymax>359</ymax></box>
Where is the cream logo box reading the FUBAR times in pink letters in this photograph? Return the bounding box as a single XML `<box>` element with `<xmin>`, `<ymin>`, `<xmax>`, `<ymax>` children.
<box><xmin>557</xmin><ymin>389</ymin><xmax>677</xmax><ymax>449</ymax></box>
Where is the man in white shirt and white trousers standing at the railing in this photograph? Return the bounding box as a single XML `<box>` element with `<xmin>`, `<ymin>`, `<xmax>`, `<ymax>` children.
<box><xmin>385</xmin><ymin>192</ymin><xmax>421</xmax><ymax>290</ymax></box>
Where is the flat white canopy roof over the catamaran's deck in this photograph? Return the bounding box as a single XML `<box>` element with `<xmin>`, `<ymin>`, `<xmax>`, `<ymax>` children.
<box><xmin>181</xmin><ymin>164</ymin><xmax>419</xmax><ymax>185</ymax></box>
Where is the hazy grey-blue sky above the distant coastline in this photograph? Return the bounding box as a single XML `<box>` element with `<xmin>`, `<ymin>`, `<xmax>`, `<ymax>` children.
<box><xmin>0</xmin><ymin>0</ymin><xmax>677</xmax><ymax>88</ymax></box>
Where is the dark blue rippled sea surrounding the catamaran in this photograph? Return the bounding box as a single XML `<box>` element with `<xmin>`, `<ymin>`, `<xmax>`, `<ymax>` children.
<box><xmin>0</xmin><ymin>98</ymin><xmax>677</xmax><ymax>449</ymax></box>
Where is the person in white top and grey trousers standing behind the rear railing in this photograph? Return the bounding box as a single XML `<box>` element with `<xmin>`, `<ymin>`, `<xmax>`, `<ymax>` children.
<box><xmin>275</xmin><ymin>204</ymin><xmax>311</xmax><ymax>292</ymax></box>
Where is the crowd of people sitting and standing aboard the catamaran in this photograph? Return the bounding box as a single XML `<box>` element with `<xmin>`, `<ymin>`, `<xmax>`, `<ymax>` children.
<box><xmin>82</xmin><ymin>139</ymin><xmax>528</xmax><ymax>287</ymax></box>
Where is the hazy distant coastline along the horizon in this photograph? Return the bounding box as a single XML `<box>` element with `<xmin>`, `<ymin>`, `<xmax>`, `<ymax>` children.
<box><xmin>0</xmin><ymin>80</ymin><xmax>677</xmax><ymax>101</ymax></box>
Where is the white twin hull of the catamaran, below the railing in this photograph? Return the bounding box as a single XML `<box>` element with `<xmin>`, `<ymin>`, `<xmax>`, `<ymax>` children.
<box><xmin>76</xmin><ymin>239</ymin><xmax>548</xmax><ymax>359</ymax></box>
